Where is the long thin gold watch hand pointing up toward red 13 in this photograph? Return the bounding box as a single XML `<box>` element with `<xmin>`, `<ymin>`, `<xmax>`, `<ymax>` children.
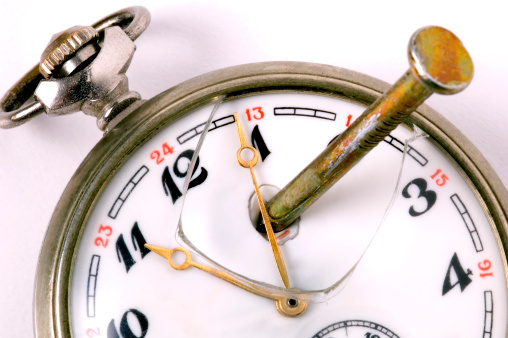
<box><xmin>235</xmin><ymin>113</ymin><xmax>290</xmax><ymax>289</ymax></box>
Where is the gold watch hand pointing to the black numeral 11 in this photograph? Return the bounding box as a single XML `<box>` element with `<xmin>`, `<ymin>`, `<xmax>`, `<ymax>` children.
<box><xmin>145</xmin><ymin>244</ymin><xmax>307</xmax><ymax>317</ymax></box>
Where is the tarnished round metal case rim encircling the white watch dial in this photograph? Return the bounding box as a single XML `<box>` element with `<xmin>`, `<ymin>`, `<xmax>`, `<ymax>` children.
<box><xmin>34</xmin><ymin>62</ymin><xmax>508</xmax><ymax>337</ymax></box>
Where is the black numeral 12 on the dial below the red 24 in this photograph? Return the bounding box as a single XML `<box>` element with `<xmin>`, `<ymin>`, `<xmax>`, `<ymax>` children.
<box><xmin>162</xmin><ymin>150</ymin><xmax>208</xmax><ymax>204</ymax></box>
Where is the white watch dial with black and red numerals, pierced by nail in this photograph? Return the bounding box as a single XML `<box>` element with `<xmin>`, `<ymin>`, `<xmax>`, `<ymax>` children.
<box><xmin>68</xmin><ymin>91</ymin><xmax>508</xmax><ymax>338</ymax></box>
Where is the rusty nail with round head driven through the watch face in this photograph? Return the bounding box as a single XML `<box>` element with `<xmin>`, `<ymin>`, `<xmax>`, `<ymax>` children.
<box><xmin>267</xmin><ymin>27</ymin><xmax>473</xmax><ymax>231</ymax></box>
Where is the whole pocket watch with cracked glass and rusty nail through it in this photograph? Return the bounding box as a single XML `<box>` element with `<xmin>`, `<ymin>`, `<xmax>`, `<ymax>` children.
<box><xmin>0</xmin><ymin>7</ymin><xmax>508</xmax><ymax>338</ymax></box>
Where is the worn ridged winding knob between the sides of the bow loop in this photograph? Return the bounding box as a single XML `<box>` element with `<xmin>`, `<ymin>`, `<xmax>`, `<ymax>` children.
<box><xmin>39</xmin><ymin>26</ymin><xmax>99</xmax><ymax>79</ymax></box>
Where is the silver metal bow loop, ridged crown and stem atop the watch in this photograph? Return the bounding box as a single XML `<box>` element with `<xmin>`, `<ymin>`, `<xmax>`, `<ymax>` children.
<box><xmin>0</xmin><ymin>6</ymin><xmax>150</xmax><ymax>130</ymax></box>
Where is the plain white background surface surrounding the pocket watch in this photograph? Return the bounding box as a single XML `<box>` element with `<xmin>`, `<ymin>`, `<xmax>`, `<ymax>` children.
<box><xmin>0</xmin><ymin>0</ymin><xmax>508</xmax><ymax>337</ymax></box>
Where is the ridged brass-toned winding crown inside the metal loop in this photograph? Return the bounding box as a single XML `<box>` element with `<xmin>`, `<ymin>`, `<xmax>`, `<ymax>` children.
<box><xmin>39</xmin><ymin>26</ymin><xmax>99</xmax><ymax>79</ymax></box>
